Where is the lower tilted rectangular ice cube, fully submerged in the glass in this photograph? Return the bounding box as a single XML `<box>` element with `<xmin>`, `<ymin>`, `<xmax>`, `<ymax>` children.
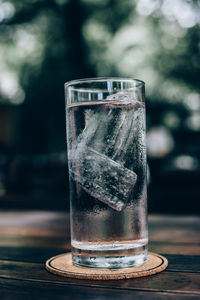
<box><xmin>70</xmin><ymin>147</ymin><xmax>137</xmax><ymax>211</ymax></box>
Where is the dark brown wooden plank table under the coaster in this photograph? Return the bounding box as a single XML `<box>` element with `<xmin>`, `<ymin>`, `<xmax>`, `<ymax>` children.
<box><xmin>0</xmin><ymin>211</ymin><xmax>200</xmax><ymax>300</ymax></box>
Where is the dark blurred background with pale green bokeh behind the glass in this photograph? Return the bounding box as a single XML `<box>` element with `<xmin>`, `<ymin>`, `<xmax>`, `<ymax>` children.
<box><xmin>0</xmin><ymin>0</ymin><xmax>200</xmax><ymax>214</ymax></box>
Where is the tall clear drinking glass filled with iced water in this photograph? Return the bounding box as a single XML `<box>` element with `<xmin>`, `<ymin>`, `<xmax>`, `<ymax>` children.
<box><xmin>65</xmin><ymin>78</ymin><xmax>148</xmax><ymax>268</ymax></box>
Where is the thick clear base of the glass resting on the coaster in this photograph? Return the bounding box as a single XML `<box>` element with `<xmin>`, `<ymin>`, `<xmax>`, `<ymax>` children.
<box><xmin>72</xmin><ymin>245</ymin><xmax>148</xmax><ymax>269</ymax></box>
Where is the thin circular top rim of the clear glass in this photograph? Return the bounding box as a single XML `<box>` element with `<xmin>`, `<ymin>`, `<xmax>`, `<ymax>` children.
<box><xmin>64</xmin><ymin>77</ymin><xmax>145</xmax><ymax>88</ymax></box>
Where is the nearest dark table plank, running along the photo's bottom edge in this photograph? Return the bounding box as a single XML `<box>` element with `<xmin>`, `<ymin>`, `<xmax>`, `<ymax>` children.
<box><xmin>0</xmin><ymin>278</ymin><xmax>199</xmax><ymax>300</ymax></box>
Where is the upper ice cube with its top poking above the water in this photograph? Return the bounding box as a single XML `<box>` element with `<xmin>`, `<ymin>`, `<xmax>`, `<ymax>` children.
<box><xmin>78</xmin><ymin>98</ymin><xmax>144</xmax><ymax>162</ymax></box>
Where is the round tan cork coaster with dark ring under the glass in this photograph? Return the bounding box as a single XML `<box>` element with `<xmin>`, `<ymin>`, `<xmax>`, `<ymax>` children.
<box><xmin>46</xmin><ymin>252</ymin><xmax>168</xmax><ymax>280</ymax></box>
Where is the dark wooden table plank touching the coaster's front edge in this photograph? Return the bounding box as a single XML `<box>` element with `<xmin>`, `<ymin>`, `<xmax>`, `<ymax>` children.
<box><xmin>0</xmin><ymin>260</ymin><xmax>200</xmax><ymax>295</ymax></box>
